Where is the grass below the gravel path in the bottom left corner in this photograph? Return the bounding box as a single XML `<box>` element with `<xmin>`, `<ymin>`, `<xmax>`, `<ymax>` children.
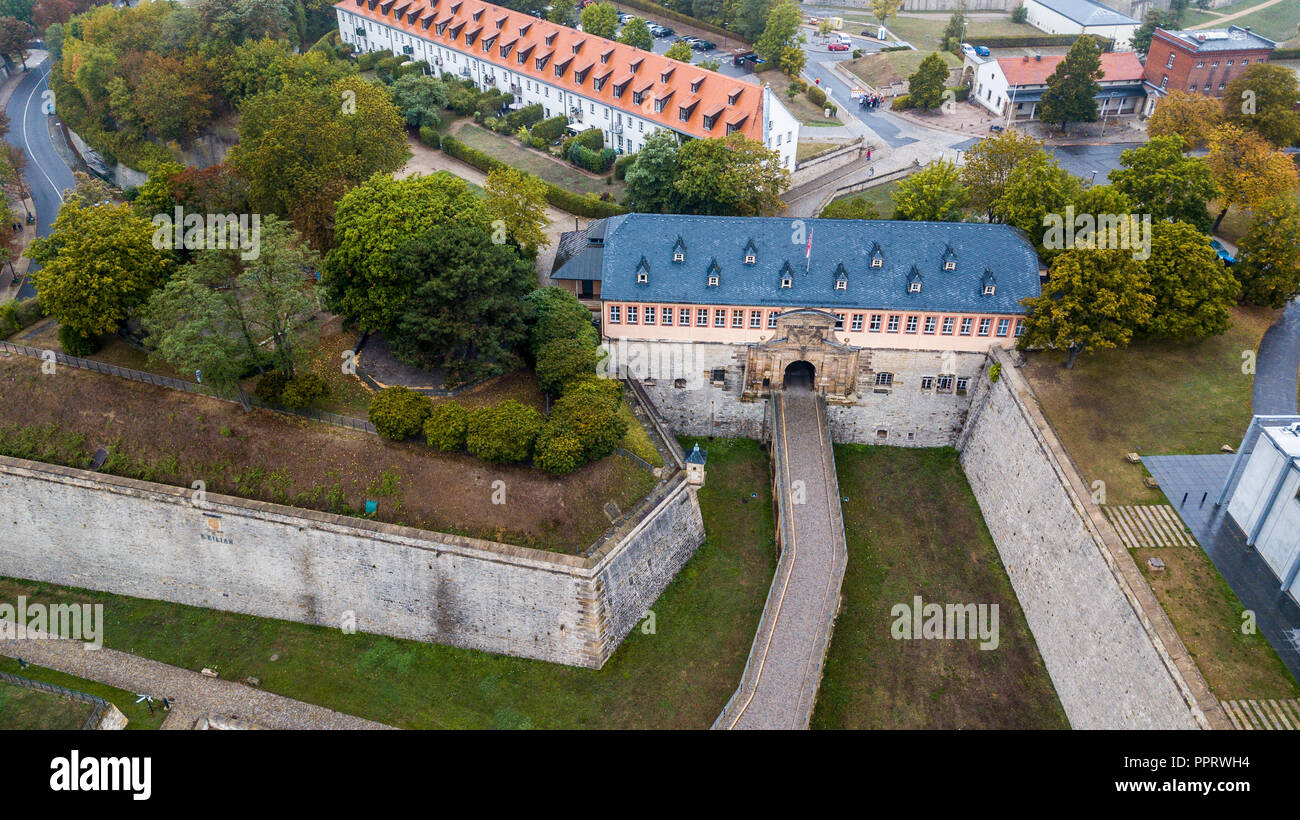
<box><xmin>0</xmin><ymin>660</ymin><xmax>166</xmax><ymax>730</ymax></box>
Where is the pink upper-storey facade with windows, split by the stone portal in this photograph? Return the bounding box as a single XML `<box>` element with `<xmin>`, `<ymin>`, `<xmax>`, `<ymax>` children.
<box><xmin>601</xmin><ymin>301</ymin><xmax>1022</xmax><ymax>352</ymax></box>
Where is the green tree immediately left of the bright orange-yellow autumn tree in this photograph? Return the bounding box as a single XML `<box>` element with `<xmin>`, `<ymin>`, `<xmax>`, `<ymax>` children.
<box><xmin>1110</xmin><ymin>135</ymin><xmax>1219</xmax><ymax>233</ymax></box>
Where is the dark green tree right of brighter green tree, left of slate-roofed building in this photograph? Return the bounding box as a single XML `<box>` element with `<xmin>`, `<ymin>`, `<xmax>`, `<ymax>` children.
<box><xmin>389</xmin><ymin>222</ymin><xmax>537</xmax><ymax>383</ymax></box>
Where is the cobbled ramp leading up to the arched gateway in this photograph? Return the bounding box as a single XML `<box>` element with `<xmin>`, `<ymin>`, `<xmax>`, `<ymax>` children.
<box><xmin>714</xmin><ymin>389</ymin><xmax>848</xmax><ymax>729</ymax></box>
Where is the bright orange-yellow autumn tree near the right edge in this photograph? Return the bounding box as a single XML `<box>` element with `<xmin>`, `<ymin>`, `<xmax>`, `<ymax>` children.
<box><xmin>1208</xmin><ymin>123</ymin><xmax>1300</xmax><ymax>230</ymax></box>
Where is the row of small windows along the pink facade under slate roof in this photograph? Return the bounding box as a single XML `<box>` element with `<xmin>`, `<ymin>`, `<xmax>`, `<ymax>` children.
<box><xmin>608</xmin><ymin>304</ymin><xmax>1024</xmax><ymax>337</ymax></box>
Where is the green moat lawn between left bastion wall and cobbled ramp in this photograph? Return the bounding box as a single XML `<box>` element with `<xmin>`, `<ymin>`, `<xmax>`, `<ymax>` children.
<box><xmin>0</xmin><ymin>439</ymin><xmax>776</xmax><ymax>729</ymax></box>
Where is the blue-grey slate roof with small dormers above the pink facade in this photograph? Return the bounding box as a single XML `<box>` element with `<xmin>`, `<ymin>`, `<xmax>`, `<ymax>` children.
<box><xmin>555</xmin><ymin>213</ymin><xmax>1040</xmax><ymax>314</ymax></box>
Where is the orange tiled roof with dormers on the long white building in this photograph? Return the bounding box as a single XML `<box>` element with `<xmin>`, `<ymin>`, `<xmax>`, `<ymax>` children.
<box><xmin>334</xmin><ymin>0</ymin><xmax>769</xmax><ymax>140</ymax></box>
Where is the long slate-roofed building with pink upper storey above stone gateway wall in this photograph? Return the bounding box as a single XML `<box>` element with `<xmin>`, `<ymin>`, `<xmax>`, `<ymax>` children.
<box><xmin>553</xmin><ymin>213</ymin><xmax>1040</xmax><ymax>351</ymax></box>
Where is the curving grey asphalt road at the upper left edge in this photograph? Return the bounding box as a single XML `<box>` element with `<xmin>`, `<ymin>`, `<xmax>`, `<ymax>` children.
<box><xmin>5</xmin><ymin>57</ymin><xmax>74</xmax><ymax>299</ymax></box>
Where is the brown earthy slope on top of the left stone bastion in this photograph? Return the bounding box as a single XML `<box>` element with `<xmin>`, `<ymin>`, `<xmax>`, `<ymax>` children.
<box><xmin>0</xmin><ymin>356</ymin><xmax>654</xmax><ymax>552</ymax></box>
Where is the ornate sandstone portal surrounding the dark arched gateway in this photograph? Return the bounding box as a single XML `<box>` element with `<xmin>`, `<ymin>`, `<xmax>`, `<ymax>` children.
<box><xmin>745</xmin><ymin>309</ymin><xmax>859</xmax><ymax>399</ymax></box>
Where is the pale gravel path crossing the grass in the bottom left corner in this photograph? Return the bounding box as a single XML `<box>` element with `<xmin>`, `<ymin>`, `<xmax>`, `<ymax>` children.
<box><xmin>0</xmin><ymin>626</ymin><xmax>391</xmax><ymax>729</ymax></box>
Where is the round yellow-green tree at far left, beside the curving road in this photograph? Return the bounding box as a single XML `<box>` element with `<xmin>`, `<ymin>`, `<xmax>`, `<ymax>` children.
<box><xmin>26</xmin><ymin>199</ymin><xmax>176</xmax><ymax>339</ymax></box>
